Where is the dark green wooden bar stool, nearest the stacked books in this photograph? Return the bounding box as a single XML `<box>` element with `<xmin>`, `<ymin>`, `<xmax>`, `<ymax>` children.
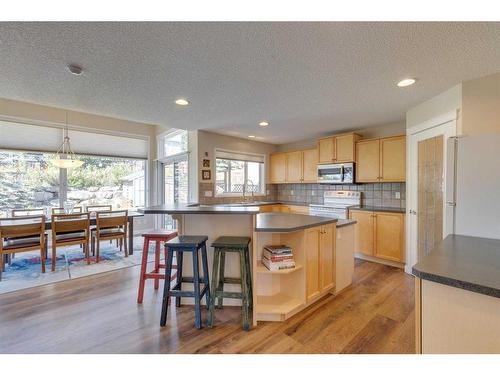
<box><xmin>207</xmin><ymin>236</ymin><xmax>253</xmax><ymax>331</ymax></box>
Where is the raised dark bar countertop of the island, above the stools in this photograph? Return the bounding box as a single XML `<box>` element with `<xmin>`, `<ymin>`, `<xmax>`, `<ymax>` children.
<box><xmin>138</xmin><ymin>204</ymin><xmax>259</xmax><ymax>215</ymax></box>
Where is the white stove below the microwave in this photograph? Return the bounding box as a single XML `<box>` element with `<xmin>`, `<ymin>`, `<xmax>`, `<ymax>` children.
<box><xmin>309</xmin><ymin>190</ymin><xmax>361</xmax><ymax>219</ymax></box>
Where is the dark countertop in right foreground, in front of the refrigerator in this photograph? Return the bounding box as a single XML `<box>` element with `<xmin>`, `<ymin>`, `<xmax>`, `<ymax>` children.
<box><xmin>412</xmin><ymin>235</ymin><xmax>500</xmax><ymax>298</ymax></box>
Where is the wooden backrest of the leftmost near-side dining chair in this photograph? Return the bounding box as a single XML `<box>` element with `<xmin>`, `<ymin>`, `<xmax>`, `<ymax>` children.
<box><xmin>0</xmin><ymin>215</ymin><xmax>45</xmax><ymax>242</ymax></box>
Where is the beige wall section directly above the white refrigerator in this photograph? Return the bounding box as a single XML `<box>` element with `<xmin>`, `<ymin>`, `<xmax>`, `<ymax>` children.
<box><xmin>462</xmin><ymin>73</ymin><xmax>500</xmax><ymax>135</ymax></box>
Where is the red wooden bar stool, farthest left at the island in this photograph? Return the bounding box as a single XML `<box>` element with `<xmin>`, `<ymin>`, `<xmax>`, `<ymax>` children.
<box><xmin>137</xmin><ymin>229</ymin><xmax>177</xmax><ymax>303</ymax></box>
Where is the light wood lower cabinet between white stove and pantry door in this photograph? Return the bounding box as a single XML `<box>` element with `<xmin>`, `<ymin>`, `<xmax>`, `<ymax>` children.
<box><xmin>349</xmin><ymin>210</ymin><xmax>405</xmax><ymax>263</ymax></box>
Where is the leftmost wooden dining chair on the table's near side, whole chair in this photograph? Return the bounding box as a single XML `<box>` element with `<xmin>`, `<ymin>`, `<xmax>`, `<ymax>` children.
<box><xmin>0</xmin><ymin>215</ymin><xmax>47</xmax><ymax>281</ymax></box>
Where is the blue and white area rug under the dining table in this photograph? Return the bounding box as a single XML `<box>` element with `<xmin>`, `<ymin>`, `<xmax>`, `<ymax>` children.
<box><xmin>0</xmin><ymin>237</ymin><xmax>161</xmax><ymax>294</ymax></box>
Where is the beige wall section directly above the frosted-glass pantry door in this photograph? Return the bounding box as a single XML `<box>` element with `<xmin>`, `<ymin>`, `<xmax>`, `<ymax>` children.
<box><xmin>406</xmin><ymin>84</ymin><xmax>462</xmax><ymax>133</ymax></box>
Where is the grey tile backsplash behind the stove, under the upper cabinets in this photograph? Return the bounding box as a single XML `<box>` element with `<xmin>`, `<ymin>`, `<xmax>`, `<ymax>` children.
<box><xmin>276</xmin><ymin>182</ymin><xmax>406</xmax><ymax>208</ymax></box>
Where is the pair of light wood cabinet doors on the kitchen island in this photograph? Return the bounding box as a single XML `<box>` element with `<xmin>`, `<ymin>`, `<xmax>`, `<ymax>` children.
<box><xmin>306</xmin><ymin>224</ymin><xmax>336</xmax><ymax>302</ymax></box>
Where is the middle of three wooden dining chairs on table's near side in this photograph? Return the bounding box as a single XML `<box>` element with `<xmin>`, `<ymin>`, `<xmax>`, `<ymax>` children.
<box><xmin>52</xmin><ymin>212</ymin><xmax>90</xmax><ymax>271</ymax></box>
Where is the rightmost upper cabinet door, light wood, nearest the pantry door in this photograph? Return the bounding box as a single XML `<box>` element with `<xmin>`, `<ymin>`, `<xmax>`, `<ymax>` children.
<box><xmin>380</xmin><ymin>136</ymin><xmax>406</xmax><ymax>181</ymax></box>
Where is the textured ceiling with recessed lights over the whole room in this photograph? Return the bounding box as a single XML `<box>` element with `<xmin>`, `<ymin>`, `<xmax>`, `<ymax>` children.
<box><xmin>0</xmin><ymin>22</ymin><xmax>500</xmax><ymax>144</ymax></box>
